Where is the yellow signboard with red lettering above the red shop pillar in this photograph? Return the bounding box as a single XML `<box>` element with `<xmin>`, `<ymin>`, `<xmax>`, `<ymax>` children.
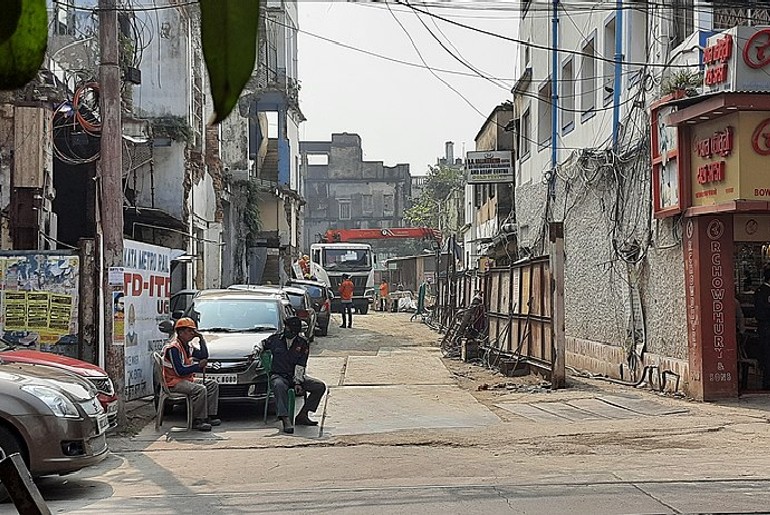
<box><xmin>689</xmin><ymin>111</ymin><xmax>770</xmax><ymax>206</ymax></box>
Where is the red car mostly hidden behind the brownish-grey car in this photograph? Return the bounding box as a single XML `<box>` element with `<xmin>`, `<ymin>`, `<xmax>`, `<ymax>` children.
<box><xmin>0</xmin><ymin>338</ymin><xmax>118</xmax><ymax>428</ymax></box>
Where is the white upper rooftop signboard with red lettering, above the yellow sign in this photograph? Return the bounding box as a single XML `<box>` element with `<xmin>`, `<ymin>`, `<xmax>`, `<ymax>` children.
<box><xmin>703</xmin><ymin>26</ymin><xmax>770</xmax><ymax>94</ymax></box>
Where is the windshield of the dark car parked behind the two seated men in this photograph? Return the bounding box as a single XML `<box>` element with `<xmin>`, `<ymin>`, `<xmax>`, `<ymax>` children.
<box><xmin>191</xmin><ymin>299</ymin><xmax>280</xmax><ymax>332</ymax></box>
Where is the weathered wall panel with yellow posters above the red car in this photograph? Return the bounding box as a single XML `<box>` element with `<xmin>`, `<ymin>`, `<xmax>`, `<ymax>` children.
<box><xmin>0</xmin><ymin>252</ymin><xmax>80</xmax><ymax>358</ymax></box>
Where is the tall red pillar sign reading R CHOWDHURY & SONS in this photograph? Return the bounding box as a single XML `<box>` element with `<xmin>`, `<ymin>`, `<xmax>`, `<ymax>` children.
<box><xmin>684</xmin><ymin>215</ymin><xmax>738</xmax><ymax>400</ymax></box>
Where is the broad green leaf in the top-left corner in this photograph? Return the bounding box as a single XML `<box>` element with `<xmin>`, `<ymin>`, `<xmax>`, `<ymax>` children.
<box><xmin>0</xmin><ymin>0</ymin><xmax>48</xmax><ymax>90</ymax></box>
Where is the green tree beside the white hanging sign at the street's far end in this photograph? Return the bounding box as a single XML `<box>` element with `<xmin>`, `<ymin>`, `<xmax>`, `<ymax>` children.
<box><xmin>404</xmin><ymin>165</ymin><xmax>464</xmax><ymax>228</ymax></box>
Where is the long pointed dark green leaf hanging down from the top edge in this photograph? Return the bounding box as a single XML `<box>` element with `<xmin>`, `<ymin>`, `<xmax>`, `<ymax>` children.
<box><xmin>200</xmin><ymin>0</ymin><xmax>260</xmax><ymax>123</ymax></box>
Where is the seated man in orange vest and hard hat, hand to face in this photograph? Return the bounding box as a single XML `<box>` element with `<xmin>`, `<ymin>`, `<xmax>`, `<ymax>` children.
<box><xmin>161</xmin><ymin>317</ymin><xmax>222</xmax><ymax>431</ymax></box>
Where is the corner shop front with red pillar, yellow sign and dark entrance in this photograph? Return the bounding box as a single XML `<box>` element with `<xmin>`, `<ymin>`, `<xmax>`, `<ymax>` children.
<box><xmin>656</xmin><ymin>97</ymin><xmax>770</xmax><ymax>400</ymax></box>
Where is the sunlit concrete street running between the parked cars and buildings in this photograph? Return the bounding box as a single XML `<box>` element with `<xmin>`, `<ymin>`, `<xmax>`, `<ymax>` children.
<box><xmin>7</xmin><ymin>312</ymin><xmax>770</xmax><ymax>515</ymax></box>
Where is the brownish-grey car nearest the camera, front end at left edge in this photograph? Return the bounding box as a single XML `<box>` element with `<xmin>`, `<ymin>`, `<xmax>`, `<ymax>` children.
<box><xmin>0</xmin><ymin>363</ymin><xmax>109</xmax><ymax>500</ymax></box>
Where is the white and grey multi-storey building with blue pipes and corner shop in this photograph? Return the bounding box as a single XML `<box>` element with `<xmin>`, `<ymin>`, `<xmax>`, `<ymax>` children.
<box><xmin>513</xmin><ymin>0</ymin><xmax>770</xmax><ymax>399</ymax></box>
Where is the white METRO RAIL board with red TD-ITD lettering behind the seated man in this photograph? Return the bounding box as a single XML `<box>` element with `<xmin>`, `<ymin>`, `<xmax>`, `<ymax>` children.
<box><xmin>121</xmin><ymin>240</ymin><xmax>172</xmax><ymax>400</ymax></box>
